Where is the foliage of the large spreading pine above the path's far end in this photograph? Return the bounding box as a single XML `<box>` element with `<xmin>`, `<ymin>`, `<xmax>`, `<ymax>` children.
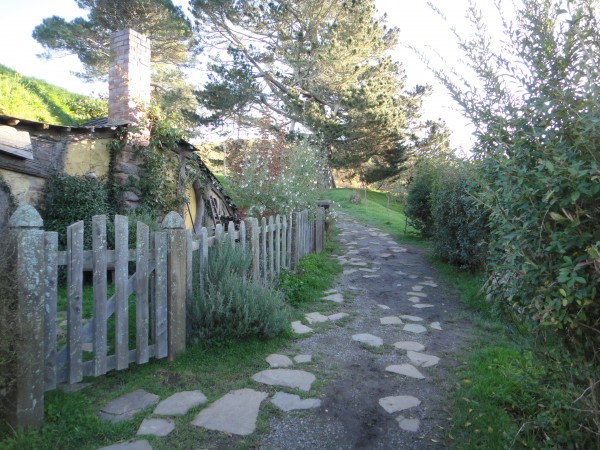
<box><xmin>191</xmin><ymin>0</ymin><xmax>429</xmax><ymax>181</ymax></box>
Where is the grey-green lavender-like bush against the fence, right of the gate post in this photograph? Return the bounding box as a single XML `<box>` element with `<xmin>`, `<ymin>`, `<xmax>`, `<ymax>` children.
<box><xmin>188</xmin><ymin>240</ymin><xmax>288</xmax><ymax>342</ymax></box>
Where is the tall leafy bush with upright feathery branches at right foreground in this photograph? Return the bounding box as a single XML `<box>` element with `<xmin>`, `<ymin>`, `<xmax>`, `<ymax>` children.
<box><xmin>424</xmin><ymin>0</ymin><xmax>600</xmax><ymax>363</ymax></box>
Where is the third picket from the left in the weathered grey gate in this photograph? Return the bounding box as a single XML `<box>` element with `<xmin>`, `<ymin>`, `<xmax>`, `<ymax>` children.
<box><xmin>92</xmin><ymin>215</ymin><xmax>108</xmax><ymax>376</ymax></box>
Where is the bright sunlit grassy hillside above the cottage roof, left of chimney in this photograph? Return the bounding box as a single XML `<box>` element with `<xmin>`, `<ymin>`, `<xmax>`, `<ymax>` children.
<box><xmin>0</xmin><ymin>65</ymin><xmax>108</xmax><ymax>125</ymax></box>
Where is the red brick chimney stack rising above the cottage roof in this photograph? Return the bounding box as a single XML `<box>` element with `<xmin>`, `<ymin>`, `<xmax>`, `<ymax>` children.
<box><xmin>108</xmin><ymin>29</ymin><xmax>151</xmax><ymax>123</ymax></box>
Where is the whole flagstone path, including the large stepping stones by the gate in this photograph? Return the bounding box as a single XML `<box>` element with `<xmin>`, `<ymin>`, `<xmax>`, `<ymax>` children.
<box><xmin>99</xmin><ymin>215</ymin><xmax>470</xmax><ymax>450</ymax></box>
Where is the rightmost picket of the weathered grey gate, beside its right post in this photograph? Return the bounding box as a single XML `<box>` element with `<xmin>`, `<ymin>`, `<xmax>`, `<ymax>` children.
<box><xmin>154</xmin><ymin>231</ymin><xmax>169</xmax><ymax>359</ymax></box>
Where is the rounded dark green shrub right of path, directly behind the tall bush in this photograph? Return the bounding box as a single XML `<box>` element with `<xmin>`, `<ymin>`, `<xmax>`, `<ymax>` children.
<box><xmin>430</xmin><ymin>161</ymin><xmax>489</xmax><ymax>270</ymax></box>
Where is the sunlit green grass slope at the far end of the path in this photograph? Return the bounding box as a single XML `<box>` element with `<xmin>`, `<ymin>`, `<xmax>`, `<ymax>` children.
<box><xmin>325</xmin><ymin>188</ymin><xmax>425</xmax><ymax>245</ymax></box>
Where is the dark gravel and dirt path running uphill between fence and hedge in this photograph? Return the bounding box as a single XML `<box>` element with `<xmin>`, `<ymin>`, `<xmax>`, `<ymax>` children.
<box><xmin>259</xmin><ymin>215</ymin><xmax>471</xmax><ymax>450</ymax></box>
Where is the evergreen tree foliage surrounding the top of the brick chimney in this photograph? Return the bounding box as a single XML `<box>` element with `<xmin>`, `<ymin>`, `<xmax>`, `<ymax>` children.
<box><xmin>33</xmin><ymin>0</ymin><xmax>200</xmax><ymax>128</ymax></box>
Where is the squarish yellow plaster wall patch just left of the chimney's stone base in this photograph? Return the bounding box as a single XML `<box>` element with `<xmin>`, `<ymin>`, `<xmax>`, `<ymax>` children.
<box><xmin>63</xmin><ymin>139</ymin><xmax>111</xmax><ymax>177</ymax></box>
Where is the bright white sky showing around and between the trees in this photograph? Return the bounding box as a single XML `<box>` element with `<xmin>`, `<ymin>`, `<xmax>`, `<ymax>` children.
<box><xmin>0</xmin><ymin>0</ymin><xmax>506</xmax><ymax>150</ymax></box>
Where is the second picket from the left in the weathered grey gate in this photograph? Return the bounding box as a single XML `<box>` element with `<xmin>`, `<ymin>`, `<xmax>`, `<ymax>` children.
<box><xmin>67</xmin><ymin>221</ymin><xmax>83</xmax><ymax>383</ymax></box>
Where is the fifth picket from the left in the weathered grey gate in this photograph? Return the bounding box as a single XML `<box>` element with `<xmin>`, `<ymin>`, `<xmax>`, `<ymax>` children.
<box><xmin>135</xmin><ymin>222</ymin><xmax>150</xmax><ymax>364</ymax></box>
